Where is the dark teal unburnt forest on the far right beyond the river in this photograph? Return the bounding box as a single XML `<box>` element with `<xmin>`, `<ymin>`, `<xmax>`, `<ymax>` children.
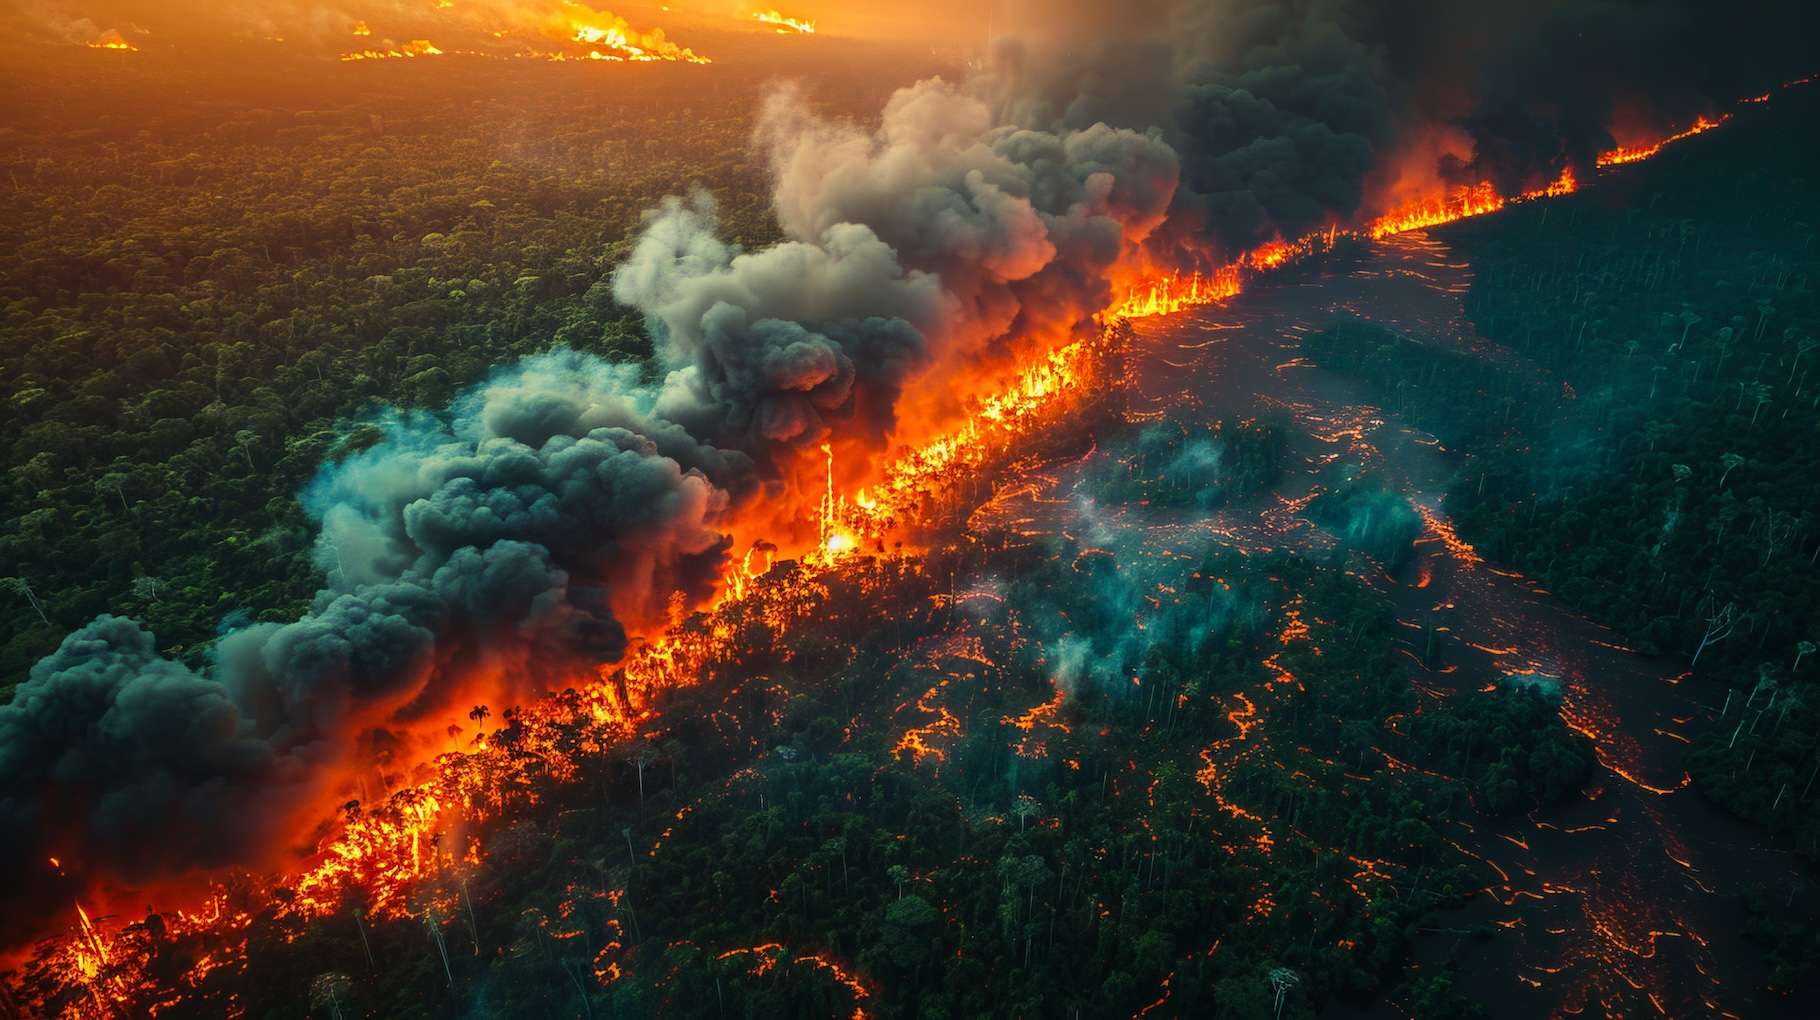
<box><xmin>1307</xmin><ymin>97</ymin><xmax>1820</xmax><ymax>892</ymax></box>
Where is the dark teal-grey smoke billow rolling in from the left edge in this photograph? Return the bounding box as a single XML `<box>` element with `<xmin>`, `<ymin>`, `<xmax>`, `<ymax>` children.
<box><xmin>0</xmin><ymin>352</ymin><xmax>738</xmax><ymax>920</ymax></box>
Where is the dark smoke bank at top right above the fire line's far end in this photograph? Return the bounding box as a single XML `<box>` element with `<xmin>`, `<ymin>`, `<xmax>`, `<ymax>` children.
<box><xmin>985</xmin><ymin>0</ymin><xmax>1820</xmax><ymax>268</ymax></box>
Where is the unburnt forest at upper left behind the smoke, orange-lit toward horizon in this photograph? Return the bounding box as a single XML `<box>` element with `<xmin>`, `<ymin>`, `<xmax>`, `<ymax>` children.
<box><xmin>0</xmin><ymin>53</ymin><xmax>939</xmax><ymax>696</ymax></box>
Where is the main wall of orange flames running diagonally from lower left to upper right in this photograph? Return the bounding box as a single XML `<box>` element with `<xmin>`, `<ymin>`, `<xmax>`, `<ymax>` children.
<box><xmin>10</xmin><ymin>79</ymin><xmax>1776</xmax><ymax>1016</ymax></box>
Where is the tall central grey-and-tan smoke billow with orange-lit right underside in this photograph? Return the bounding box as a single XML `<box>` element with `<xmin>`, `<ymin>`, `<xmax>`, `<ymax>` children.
<box><xmin>613</xmin><ymin>80</ymin><xmax>1178</xmax><ymax>464</ymax></box>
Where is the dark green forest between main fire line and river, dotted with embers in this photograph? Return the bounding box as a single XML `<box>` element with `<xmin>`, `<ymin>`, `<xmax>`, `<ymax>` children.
<box><xmin>56</xmin><ymin>536</ymin><xmax>1587</xmax><ymax>1018</ymax></box>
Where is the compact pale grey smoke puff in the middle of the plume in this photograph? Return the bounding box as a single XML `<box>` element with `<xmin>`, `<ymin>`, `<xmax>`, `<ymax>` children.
<box><xmin>613</xmin><ymin>195</ymin><xmax>948</xmax><ymax>455</ymax></box>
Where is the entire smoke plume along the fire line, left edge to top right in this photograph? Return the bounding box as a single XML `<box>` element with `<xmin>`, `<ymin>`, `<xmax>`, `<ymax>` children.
<box><xmin>0</xmin><ymin>0</ymin><xmax>1804</xmax><ymax>947</ymax></box>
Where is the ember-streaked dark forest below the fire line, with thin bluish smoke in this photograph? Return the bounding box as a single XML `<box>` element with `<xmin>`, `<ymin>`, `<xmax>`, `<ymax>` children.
<box><xmin>7</xmin><ymin>389</ymin><xmax>1565</xmax><ymax>1015</ymax></box>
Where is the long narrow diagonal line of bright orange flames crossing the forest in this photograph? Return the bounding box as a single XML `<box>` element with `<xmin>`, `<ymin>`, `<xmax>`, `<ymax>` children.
<box><xmin>32</xmin><ymin>73</ymin><xmax>1802</xmax><ymax>1015</ymax></box>
